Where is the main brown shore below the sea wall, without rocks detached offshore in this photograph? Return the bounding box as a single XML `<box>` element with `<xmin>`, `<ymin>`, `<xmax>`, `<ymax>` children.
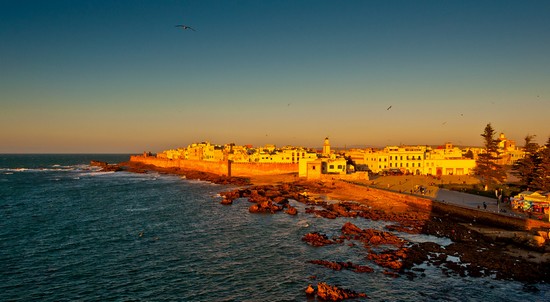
<box><xmin>113</xmin><ymin>162</ymin><xmax>550</xmax><ymax>292</ymax></box>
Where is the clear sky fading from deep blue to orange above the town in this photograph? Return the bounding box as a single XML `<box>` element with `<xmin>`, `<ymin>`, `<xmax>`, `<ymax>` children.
<box><xmin>0</xmin><ymin>0</ymin><xmax>550</xmax><ymax>153</ymax></box>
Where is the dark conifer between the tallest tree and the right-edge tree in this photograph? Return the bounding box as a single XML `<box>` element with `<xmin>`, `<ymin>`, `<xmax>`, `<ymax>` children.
<box><xmin>512</xmin><ymin>134</ymin><xmax>540</xmax><ymax>188</ymax></box>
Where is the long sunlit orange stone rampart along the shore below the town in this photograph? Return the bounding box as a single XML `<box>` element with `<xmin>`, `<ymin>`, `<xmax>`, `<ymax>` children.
<box><xmin>130</xmin><ymin>155</ymin><xmax>298</xmax><ymax>176</ymax></box>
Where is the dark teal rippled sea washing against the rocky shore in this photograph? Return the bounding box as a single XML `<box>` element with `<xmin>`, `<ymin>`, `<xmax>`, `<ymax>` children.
<box><xmin>0</xmin><ymin>154</ymin><xmax>550</xmax><ymax>301</ymax></box>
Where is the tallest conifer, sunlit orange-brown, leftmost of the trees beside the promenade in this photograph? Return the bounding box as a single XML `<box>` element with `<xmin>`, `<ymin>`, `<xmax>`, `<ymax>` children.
<box><xmin>474</xmin><ymin>123</ymin><xmax>506</xmax><ymax>189</ymax></box>
